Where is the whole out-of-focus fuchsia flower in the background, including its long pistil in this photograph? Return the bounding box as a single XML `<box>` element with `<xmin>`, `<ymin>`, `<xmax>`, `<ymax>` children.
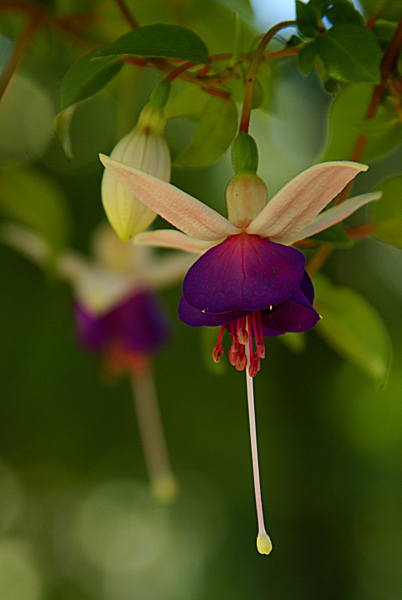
<box><xmin>1</xmin><ymin>224</ymin><xmax>193</xmax><ymax>501</ymax></box>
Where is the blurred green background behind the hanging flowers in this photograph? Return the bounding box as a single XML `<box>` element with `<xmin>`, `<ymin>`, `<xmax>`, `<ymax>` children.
<box><xmin>0</xmin><ymin>3</ymin><xmax>402</xmax><ymax>600</ymax></box>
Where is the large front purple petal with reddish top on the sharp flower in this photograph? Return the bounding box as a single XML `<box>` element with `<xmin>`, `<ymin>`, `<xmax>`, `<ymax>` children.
<box><xmin>183</xmin><ymin>233</ymin><xmax>305</xmax><ymax>313</ymax></box>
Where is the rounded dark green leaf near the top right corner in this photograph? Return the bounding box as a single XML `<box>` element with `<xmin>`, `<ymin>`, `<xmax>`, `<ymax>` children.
<box><xmin>317</xmin><ymin>23</ymin><xmax>382</xmax><ymax>83</ymax></box>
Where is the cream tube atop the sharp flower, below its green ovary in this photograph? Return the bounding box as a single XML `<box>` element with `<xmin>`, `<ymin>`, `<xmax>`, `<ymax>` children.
<box><xmin>226</xmin><ymin>173</ymin><xmax>268</xmax><ymax>228</ymax></box>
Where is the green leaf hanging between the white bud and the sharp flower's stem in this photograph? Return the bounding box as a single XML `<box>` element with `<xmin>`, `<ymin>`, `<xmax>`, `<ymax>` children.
<box><xmin>173</xmin><ymin>96</ymin><xmax>237</xmax><ymax>168</ymax></box>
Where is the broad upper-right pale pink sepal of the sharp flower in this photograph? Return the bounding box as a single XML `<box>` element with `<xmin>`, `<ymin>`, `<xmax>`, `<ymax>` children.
<box><xmin>246</xmin><ymin>161</ymin><xmax>368</xmax><ymax>242</ymax></box>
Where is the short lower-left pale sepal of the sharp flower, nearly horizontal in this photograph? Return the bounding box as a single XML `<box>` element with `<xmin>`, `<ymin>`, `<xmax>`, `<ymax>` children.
<box><xmin>133</xmin><ymin>229</ymin><xmax>217</xmax><ymax>254</ymax></box>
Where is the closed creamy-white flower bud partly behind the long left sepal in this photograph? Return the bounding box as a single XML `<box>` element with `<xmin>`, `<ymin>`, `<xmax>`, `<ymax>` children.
<box><xmin>102</xmin><ymin>105</ymin><xmax>171</xmax><ymax>242</ymax></box>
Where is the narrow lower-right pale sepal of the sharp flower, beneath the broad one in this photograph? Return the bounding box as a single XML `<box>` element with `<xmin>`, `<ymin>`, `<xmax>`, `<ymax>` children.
<box><xmin>282</xmin><ymin>192</ymin><xmax>382</xmax><ymax>245</ymax></box>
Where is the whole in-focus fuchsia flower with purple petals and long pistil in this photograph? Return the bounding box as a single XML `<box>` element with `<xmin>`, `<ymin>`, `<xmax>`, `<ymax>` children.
<box><xmin>101</xmin><ymin>142</ymin><xmax>380</xmax><ymax>554</ymax></box>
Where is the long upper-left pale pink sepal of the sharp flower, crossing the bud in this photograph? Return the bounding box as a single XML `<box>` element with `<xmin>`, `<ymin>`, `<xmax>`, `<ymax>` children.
<box><xmin>99</xmin><ymin>154</ymin><xmax>239</xmax><ymax>241</ymax></box>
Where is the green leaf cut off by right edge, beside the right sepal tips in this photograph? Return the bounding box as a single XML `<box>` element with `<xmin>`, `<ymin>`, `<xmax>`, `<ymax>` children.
<box><xmin>370</xmin><ymin>175</ymin><xmax>402</xmax><ymax>248</ymax></box>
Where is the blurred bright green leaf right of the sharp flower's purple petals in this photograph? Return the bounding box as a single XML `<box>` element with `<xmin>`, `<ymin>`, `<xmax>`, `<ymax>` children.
<box><xmin>314</xmin><ymin>275</ymin><xmax>391</xmax><ymax>385</ymax></box>
